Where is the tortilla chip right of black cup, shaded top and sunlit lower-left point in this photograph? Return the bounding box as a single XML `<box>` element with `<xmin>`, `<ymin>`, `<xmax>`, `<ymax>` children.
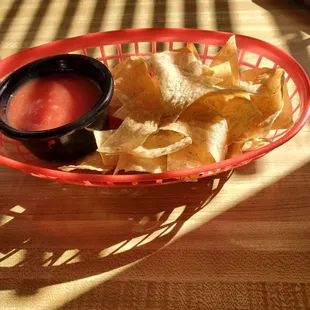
<box><xmin>98</xmin><ymin>111</ymin><xmax>160</xmax><ymax>154</ymax></box>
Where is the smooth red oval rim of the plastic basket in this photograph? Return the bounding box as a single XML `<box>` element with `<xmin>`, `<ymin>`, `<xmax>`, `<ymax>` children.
<box><xmin>0</xmin><ymin>28</ymin><xmax>310</xmax><ymax>184</ymax></box>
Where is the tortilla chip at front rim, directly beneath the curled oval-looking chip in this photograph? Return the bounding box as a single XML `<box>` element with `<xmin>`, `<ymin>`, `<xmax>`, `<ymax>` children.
<box><xmin>114</xmin><ymin>154</ymin><xmax>167</xmax><ymax>174</ymax></box>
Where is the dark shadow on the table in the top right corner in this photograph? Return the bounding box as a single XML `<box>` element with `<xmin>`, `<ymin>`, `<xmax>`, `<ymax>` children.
<box><xmin>252</xmin><ymin>0</ymin><xmax>310</xmax><ymax>75</ymax></box>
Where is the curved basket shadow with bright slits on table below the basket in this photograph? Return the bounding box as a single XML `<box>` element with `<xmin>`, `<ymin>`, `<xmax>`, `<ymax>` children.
<box><xmin>0</xmin><ymin>171</ymin><xmax>230</xmax><ymax>295</ymax></box>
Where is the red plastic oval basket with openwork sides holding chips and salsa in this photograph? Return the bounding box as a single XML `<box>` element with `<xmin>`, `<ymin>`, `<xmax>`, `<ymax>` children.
<box><xmin>0</xmin><ymin>29</ymin><xmax>310</xmax><ymax>187</ymax></box>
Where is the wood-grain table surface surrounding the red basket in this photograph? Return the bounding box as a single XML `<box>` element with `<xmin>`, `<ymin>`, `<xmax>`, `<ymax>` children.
<box><xmin>0</xmin><ymin>0</ymin><xmax>310</xmax><ymax>309</ymax></box>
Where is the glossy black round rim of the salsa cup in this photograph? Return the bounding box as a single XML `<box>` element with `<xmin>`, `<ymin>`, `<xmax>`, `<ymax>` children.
<box><xmin>0</xmin><ymin>54</ymin><xmax>114</xmax><ymax>141</ymax></box>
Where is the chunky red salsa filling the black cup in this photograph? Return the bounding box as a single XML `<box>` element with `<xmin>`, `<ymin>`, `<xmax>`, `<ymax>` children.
<box><xmin>6</xmin><ymin>73</ymin><xmax>102</xmax><ymax>131</ymax></box>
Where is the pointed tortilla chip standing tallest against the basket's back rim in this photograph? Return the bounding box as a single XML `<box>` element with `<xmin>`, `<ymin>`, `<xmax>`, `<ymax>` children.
<box><xmin>210</xmin><ymin>36</ymin><xmax>240</xmax><ymax>86</ymax></box>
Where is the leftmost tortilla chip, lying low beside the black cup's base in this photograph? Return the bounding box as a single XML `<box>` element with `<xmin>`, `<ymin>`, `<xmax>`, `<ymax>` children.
<box><xmin>58</xmin><ymin>152</ymin><xmax>113</xmax><ymax>173</ymax></box>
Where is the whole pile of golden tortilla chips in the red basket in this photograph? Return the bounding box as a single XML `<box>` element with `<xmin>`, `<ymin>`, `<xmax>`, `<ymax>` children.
<box><xmin>59</xmin><ymin>36</ymin><xmax>293</xmax><ymax>174</ymax></box>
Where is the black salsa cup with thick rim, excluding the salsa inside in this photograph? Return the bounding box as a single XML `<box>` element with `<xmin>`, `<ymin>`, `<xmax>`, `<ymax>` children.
<box><xmin>0</xmin><ymin>54</ymin><xmax>113</xmax><ymax>162</ymax></box>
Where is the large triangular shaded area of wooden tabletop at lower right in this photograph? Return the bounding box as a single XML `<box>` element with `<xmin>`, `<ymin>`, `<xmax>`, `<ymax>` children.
<box><xmin>55</xmin><ymin>163</ymin><xmax>310</xmax><ymax>310</ymax></box>
